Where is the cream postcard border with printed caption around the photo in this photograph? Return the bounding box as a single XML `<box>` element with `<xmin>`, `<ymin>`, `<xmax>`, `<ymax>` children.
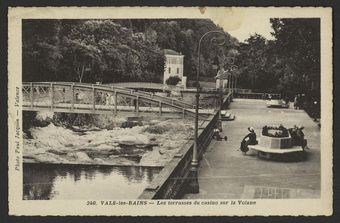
<box><xmin>8</xmin><ymin>7</ymin><xmax>333</xmax><ymax>216</ymax></box>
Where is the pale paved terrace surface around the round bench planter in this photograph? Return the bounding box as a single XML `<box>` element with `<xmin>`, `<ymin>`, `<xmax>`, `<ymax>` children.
<box><xmin>184</xmin><ymin>99</ymin><xmax>320</xmax><ymax>199</ymax></box>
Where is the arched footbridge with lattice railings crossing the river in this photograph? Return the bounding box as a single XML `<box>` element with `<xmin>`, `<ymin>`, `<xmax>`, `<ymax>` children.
<box><xmin>22</xmin><ymin>82</ymin><xmax>230</xmax><ymax>118</ymax></box>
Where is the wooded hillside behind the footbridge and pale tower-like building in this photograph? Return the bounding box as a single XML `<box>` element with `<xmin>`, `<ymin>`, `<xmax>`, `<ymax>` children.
<box><xmin>23</xmin><ymin>19</ymin><xmax>237</xmax><ymax>83</ymax></box>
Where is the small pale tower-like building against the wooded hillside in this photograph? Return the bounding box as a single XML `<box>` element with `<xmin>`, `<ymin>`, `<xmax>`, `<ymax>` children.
<box><xmin>163</xmin><ymin>49</ymin><xmax>186</xmax><ymax>86</ymax></box>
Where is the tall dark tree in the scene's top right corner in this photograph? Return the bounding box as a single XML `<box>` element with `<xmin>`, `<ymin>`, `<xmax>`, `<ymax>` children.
<box><xmin>270</xmin><ymin>18</ymin><xmax>320</xmax><ymax>93</ymax></box>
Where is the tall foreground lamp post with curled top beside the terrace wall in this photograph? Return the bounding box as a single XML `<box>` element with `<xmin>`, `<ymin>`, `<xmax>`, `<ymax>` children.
<box><xmin>189</xmin><ymin>30</ymin><xmax>225</xmax><ymax>194</ymax></box>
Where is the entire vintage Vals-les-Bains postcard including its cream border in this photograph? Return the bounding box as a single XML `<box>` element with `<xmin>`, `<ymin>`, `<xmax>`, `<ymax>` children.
<box><xmin>8</xmin><ymin>7</ymin><xmax>333</xmax><ymax>216</ymax></box>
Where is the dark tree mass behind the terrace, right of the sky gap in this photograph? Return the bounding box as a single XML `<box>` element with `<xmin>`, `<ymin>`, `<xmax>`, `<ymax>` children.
<box><xmin>237</xmin><ymin>19</ymin><xmax>320</xmax><ymax>99</ymax></box>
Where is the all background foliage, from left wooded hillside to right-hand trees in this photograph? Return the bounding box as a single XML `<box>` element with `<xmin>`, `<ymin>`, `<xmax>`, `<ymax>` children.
<box><xmin>22</xmin><ymin>19</ymin><xmax>320</xmax><ymax>102</ymax></box>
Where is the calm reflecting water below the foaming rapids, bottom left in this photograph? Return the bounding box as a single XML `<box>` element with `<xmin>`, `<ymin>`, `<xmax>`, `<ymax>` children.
<box><xmin>23</xmin><ymin>164</ymin><xmax>161</xmax><ymax>200</ymax></box>
